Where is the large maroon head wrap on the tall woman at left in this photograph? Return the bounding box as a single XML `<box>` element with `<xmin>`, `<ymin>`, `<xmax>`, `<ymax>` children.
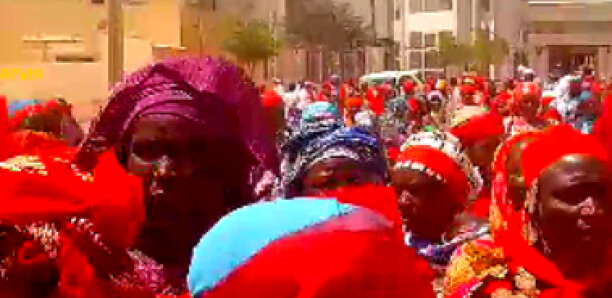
<box><xmin>79</xmin><ymin>57</ymin><xmax>278</xmax><ymax>170</ymax></box>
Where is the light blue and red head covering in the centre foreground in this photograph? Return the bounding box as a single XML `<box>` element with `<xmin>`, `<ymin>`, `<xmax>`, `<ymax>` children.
<box><xmin>188</xmin><ymin>198</ymin><xmax>434</xmax><ymax>298</ymax></box>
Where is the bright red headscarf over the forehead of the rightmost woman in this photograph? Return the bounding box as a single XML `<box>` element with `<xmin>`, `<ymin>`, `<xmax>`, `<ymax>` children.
<box><xmin>523</xmin><ymin>125</ymin><xmax>609</xmax><ymax>185</ymax></box>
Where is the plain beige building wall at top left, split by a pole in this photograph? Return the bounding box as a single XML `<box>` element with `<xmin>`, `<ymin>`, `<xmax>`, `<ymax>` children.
<box><xmin>0</xmin><ymin>0</ymin><xmax>180</xmax><ymax>121</ymax></box>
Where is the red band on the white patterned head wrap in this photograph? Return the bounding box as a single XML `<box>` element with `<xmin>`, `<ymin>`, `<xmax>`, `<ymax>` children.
<box><xmin>398</xmin><ymin>146</ymin><xmax>470</xmax><ymax>204</ymax></box>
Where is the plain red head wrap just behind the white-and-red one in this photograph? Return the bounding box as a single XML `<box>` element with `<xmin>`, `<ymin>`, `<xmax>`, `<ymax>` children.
<box><xmin>450</xmin><ymin>113</ymin><xmax>505</xmax><ymax>147</ymax></box>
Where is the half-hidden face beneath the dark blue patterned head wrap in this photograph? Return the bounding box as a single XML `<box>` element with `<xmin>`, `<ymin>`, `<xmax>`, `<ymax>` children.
<box><xmin>300</xmin><ymin>158</ymin><xmax>384</xmax><ymax>196</ymax></box>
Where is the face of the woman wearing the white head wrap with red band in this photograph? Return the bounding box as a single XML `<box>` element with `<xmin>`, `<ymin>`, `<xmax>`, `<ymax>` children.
<box><xmin>392</xmin><ymin>169</ymin><xmax>464</xmax><ymax>239</ymax></box>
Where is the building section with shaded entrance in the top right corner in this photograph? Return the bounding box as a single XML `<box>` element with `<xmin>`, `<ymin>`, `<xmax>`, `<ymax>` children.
<box><xmin>526</xmin><ymin>0</ymin><xmax>612</xmax><ymax>77</ymax></box>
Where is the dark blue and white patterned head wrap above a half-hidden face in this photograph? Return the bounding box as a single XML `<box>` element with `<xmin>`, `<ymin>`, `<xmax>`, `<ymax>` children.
<box><xmin>282</xmin><ymin>127</ymin><xmax>388</xmax><ymax>197</ymax></box>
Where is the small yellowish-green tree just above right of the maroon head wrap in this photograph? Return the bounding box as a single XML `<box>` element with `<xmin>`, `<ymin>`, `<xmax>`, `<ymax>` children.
<box><xmin>222</xmin><ymin>20</ymin><xmax>283</xmax><ymax>74</ymax></box>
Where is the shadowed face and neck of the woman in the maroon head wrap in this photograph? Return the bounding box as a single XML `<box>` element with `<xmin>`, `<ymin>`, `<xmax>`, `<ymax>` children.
<box><xmin>127</xmin><ymin>115</ymin><xmax>242</xmax><ymax>265</ymax></box>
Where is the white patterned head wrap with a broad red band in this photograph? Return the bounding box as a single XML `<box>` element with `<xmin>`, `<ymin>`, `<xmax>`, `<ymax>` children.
<box><xmin>395</xmin><ymin>132</ymin><xmax>483</xmax><ymax>203</ymax></box>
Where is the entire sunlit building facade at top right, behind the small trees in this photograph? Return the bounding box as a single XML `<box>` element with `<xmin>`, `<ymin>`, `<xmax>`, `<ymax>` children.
<box><xmin>394</xmin><ymin>0</ymin><xmax>612</xmax><ymax>79</ymax></box>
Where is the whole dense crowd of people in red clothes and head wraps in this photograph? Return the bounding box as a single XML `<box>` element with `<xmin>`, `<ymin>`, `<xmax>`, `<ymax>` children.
<box><xmin>0</xmin><ymin>58</ymin><xmax>612</xmax><ymax>298</ymax></box>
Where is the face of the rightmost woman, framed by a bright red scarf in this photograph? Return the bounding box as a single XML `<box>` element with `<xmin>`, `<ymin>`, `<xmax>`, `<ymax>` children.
<box><xmin>534</xmin><ymin>155</ymin><xmax>612</xmax><ymax>275</ymax></box>
